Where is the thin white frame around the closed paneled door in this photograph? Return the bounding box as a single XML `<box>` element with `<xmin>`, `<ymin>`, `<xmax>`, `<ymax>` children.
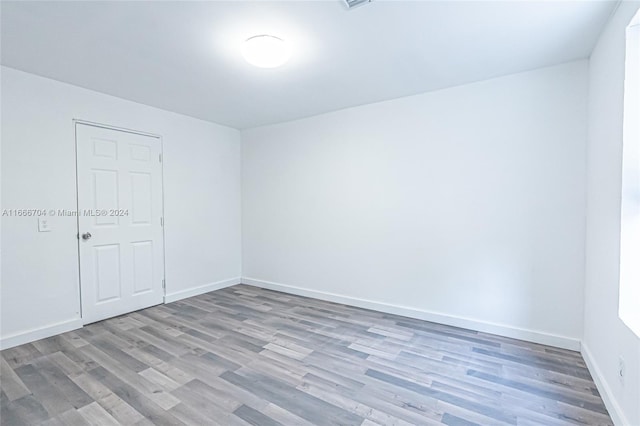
<box><xmin>71</xmin><ymin>118</ymin><xmax>167</xmax><ymax>319</ymax></box>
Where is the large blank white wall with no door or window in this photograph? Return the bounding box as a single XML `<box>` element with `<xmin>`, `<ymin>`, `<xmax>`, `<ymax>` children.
<box><xmin>242</xmin><ymin>61</ymin><xmax>587</xmax><ymax>349</ymax></box>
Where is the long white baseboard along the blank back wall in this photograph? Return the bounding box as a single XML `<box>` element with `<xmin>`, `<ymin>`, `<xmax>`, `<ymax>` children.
<box><xmin>242</xmin><ymin>277</ymin><xmax>580</xmax><ymax>351</ymax></box>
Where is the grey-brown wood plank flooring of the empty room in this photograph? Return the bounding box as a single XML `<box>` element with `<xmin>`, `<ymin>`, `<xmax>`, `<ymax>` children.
<box><xmin>0</xmin><ymin>285</ymin><xmax>612</xmax><ymax>426</ymax></box>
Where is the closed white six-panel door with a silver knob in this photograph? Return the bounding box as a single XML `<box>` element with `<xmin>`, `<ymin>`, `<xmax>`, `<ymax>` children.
<box><xmin>76</xmin><ymin>123</ymin><xmax>164</xmax><ymax>324</ymax></box>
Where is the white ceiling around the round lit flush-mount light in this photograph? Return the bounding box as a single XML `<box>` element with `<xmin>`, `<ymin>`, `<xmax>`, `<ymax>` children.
<box><xmin>1</xmin><ymin>0</ymin><xmax>616</xmax><ymax>128</ymax></box>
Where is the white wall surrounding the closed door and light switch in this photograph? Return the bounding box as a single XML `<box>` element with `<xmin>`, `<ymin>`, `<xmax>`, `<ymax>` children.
<box><xmin>0</xmin><ymin>67</ymin><xmax>241</xmax><ymax>347</ymax></box>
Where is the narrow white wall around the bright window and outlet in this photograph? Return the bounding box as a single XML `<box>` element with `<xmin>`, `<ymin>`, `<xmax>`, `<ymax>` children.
<box><xmin>583</xmin><ymin>2</ymin><xmax>640</xmax><ymax>425</ymax></box>
